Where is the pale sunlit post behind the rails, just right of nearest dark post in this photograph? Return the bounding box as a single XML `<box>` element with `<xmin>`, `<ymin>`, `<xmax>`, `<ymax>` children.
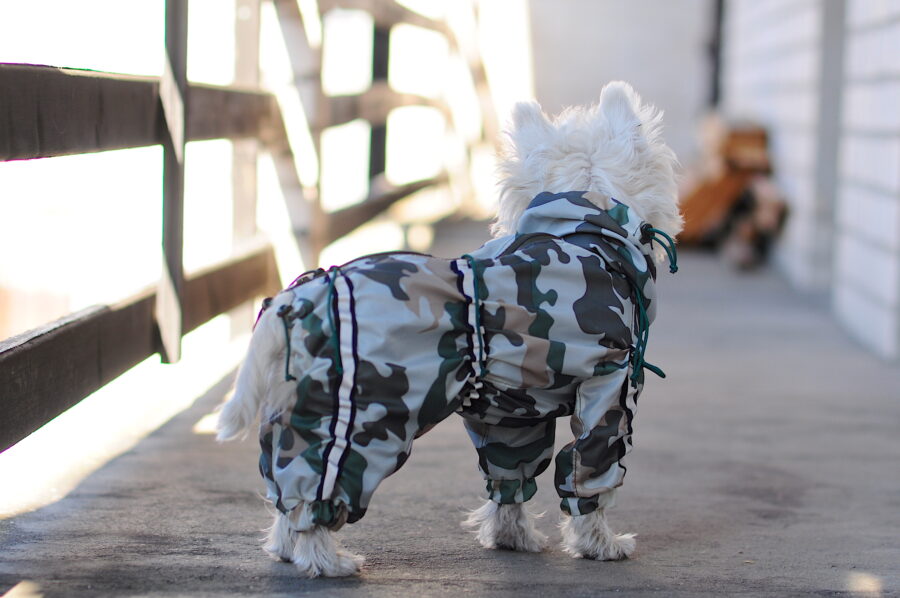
<box><xmin>229</xmin><ymin>0</ymin><xmax>260</xmax><ymax>336</ymax></box>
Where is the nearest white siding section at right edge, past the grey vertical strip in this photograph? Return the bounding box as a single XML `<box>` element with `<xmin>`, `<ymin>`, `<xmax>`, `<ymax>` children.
<box><xmin>833</xmin><ymin>0</ymin><xmax>900</xmax><ymax>358</ymax></box>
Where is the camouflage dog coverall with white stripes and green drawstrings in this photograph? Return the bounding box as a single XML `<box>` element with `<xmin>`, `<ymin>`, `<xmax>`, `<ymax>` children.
<box><xmin>260</xmin><ymin>192</ymin><xmax>674</xmax><ymax>529</ymax></box>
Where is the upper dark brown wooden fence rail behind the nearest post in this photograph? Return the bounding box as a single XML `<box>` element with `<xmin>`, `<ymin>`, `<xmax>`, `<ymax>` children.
<box><xmin>0</xmin><ymin>64</ymin><xmax>280</xmax><ymax>161</ymax></box>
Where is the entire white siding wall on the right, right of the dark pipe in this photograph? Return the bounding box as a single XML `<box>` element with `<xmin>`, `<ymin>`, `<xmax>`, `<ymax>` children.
<box><xmin>722</xmin><ymin>0</ymin><xmax>900</xmax><ymax>359</ymax></box>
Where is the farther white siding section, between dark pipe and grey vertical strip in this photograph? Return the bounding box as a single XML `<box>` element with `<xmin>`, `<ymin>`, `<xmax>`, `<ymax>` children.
<box><xmin>722</xmin><ymin>0</ymin><xmax>831</xmax><ymax>290</ymax></box>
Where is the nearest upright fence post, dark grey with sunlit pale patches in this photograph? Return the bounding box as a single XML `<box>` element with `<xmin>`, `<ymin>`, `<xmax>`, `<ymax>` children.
<box><xmin>155</xmin><ymin>0</ymin><xmax>188</xmax><ymax>363</ymax></box>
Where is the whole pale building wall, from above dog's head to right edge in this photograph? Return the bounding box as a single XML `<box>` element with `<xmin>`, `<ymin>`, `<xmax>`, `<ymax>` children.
<box><xmin>529</xmin><ymin>0</ymin><xmax>900</xmax><ymax>359</ymax></box>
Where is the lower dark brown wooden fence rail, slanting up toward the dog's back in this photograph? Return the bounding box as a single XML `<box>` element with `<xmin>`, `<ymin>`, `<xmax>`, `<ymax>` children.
<box><xmin>0</xmin><ymin>244</ymin><xmax>280</xmax><ymax>449</ymax></box>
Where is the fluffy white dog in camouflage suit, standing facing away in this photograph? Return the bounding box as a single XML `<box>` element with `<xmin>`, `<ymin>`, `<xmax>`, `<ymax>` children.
<box><xmin>218</xmin><ymin>82</ymin><xmax>682</xmax><ymax>577</ymax></box>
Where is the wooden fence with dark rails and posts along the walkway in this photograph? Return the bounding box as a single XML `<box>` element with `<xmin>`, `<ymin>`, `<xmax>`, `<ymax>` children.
<box><xmin>0</xmin><ymin>0</ymin><xmax>494</xmax><ymax>451</ymax></box>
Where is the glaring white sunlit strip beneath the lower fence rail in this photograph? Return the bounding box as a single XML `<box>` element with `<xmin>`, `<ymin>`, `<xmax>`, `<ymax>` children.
<box><xmin>0</xmin><ymin>316</ymin><xmax>249</xmax><ymax>519</ymax></box>
